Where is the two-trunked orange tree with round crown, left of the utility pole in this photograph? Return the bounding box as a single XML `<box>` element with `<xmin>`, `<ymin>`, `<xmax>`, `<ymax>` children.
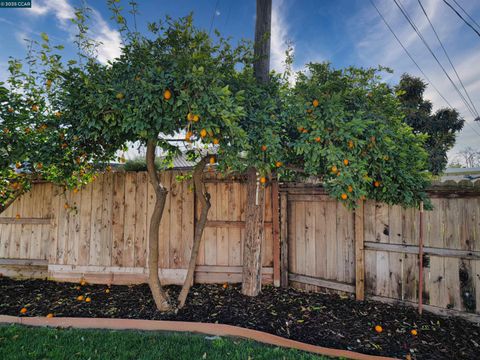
<box><xmin>56</xmin><ymin>15</ymin><xmax>248</xmax><ymax>310</ymax></box>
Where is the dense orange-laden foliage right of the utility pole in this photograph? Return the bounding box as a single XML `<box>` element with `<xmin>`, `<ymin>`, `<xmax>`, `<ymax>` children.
<box><xmin>286</xmin><ymin>63</ymin><xmax>429</xmax><ymax>207</ymax></box>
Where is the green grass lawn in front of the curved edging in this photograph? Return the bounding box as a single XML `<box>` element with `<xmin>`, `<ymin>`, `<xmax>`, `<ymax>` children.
<box><xmin>0</xmin><ymin>325</ymin><xmax>327</xmax><ymax>360</ymax></box>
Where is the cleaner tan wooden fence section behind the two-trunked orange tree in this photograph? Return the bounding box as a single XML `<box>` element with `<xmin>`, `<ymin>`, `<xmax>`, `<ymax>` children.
<box><xmin>0</xmin><ymin>171</ymin><xmax>273</xmax><ymax>283</ymax></box>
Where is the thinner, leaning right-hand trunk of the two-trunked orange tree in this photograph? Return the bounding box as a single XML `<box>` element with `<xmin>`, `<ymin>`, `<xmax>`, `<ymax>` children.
<box><xmin>178</xmin><ymin>157</ymin><xmax>211</xmax><ymax>309</ymax></box>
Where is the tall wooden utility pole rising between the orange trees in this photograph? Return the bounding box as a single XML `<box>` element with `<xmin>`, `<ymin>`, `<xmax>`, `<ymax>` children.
<box><xmin>242</xmin><ymin>0</ymin><xmax>272</xmax><ymax>296</ymax></box>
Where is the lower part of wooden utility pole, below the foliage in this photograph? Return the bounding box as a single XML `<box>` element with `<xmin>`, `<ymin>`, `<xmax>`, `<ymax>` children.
<box><xmin>242</xmin><ymin>168</ymin><xmax>265</xmax><ymax>296</ymax></box>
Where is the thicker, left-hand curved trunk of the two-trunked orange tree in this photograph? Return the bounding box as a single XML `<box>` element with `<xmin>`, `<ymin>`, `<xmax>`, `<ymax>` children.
<box><xmin>146</xmin><ymin>140</ymin><xmax>171</xmax><ymax>311</ymax></box>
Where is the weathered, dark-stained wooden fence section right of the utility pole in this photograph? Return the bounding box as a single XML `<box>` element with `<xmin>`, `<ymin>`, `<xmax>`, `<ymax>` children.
<box><xmin>280</xmin><ymin>182</ymin><xmax>480</xmax><ymax>319</ymax></box>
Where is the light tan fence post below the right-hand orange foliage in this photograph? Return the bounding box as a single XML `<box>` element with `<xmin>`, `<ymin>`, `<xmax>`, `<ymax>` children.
<box><xmin>354</xmin><ymin>200</ymin><xmax>365</xmax><ymax>300</ymax></box>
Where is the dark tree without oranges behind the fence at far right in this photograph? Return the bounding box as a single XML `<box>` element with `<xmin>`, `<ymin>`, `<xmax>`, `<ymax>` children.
<box><xmin>396</xmin><ymin>74</ymin><xmax>464</xmax><ymax>174</ymax></box>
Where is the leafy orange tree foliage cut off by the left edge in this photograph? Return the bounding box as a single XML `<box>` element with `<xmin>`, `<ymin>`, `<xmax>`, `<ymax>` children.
<box><xmin>0</xmin><ymin>34</ymin><xmax>115</xmax><ymax>212</ymax></box>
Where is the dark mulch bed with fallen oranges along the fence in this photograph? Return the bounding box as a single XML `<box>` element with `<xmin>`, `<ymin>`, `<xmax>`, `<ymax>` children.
<box><xmin>0</xmin><ymin>278</ymin><xmax>480</xmax><ymax>359</ymax></box>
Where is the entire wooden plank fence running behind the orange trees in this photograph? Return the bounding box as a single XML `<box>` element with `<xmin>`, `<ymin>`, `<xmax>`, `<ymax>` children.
<box><xmin>0</xmin><ymin>171</ymin><xmax>480</xmax><ymax>318</ymax></box>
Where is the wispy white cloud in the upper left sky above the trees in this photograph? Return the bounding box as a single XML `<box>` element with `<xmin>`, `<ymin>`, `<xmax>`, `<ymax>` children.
<box><xmin>27</xmin><ymin>0</ymin><xmax>122</xmax><ymax>63</ymax></box>
